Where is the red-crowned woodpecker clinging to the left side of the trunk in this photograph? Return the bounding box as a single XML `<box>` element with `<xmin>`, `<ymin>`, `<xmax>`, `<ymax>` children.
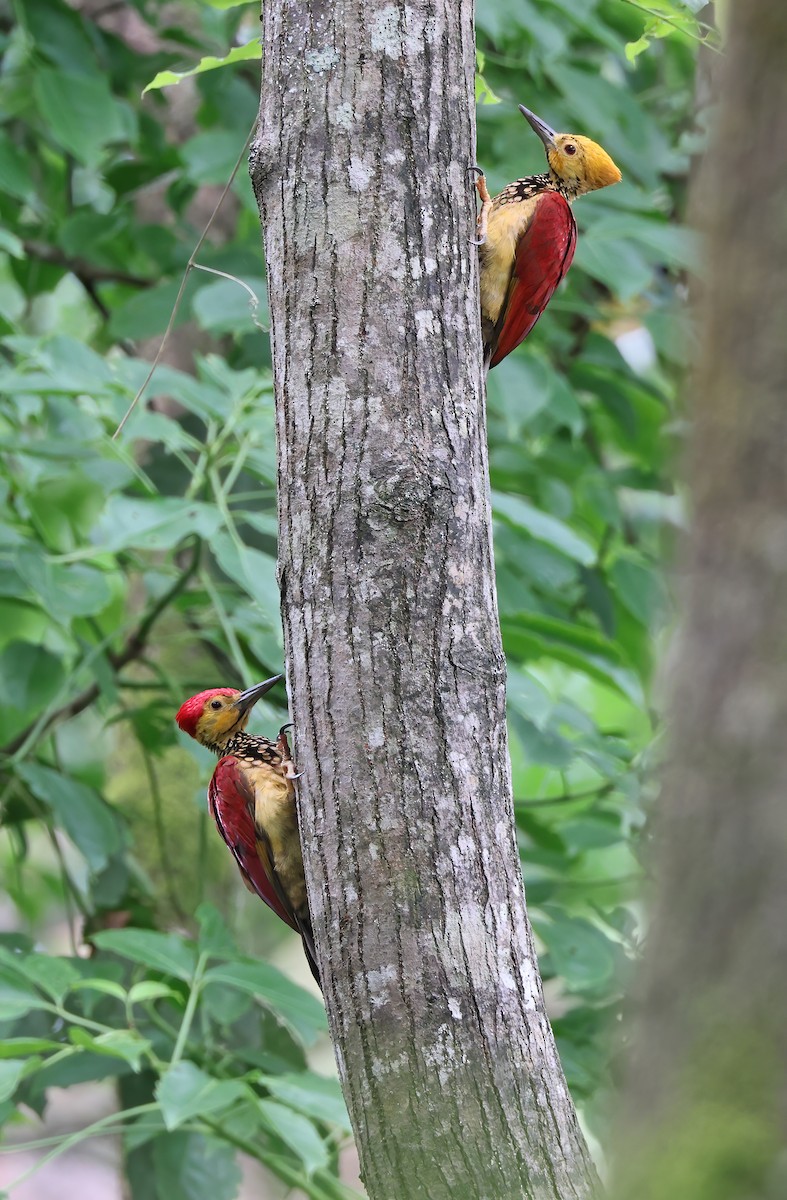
<box><xmin>175</xmin><ymin>674</ymin><xmax>320</xmax><ymax>983</ymax></box>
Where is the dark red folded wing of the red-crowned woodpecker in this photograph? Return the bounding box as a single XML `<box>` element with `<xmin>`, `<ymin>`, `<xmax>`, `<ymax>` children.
<box><xmin>208</xmin><ymin>755</ymin><xmax>301</xmax><ymax>934</ymax></box>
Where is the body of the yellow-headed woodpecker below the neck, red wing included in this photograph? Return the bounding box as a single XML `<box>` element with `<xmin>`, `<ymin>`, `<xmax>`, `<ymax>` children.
<box><xmin>476</xmin><ymin>168</ymin><xmax>577</xmax><ymax>367</ymax></box>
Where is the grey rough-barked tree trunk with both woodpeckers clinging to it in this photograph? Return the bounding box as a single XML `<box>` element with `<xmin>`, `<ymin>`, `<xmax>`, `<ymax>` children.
<box><xmin>252</xmin><ymin>0</ymin><xmax>595</xmax><ymax>1200</ymax></box>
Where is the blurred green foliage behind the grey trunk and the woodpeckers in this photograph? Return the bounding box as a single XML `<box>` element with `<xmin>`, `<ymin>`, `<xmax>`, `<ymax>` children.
<box><xmin>0</xmin><ymin>0</ymin><xmax>715</xmax><ymax>1200</ymax></box>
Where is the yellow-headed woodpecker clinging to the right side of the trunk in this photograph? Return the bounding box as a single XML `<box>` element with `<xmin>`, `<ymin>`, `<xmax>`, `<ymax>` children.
<box><xmin>473</xmin><ymin>104</ymin><xmax>620</xmax><ymax>370</ymax></box>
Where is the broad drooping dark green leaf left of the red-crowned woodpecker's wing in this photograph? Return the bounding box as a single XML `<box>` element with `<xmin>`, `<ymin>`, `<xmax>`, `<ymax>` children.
<box><xmin>17</xmin><ymin>762</ymin><xmax>121</xmax><ymax>872</ymax></box>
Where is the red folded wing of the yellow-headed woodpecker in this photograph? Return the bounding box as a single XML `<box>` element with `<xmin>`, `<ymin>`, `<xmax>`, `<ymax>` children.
<box><xmin>489</xmin><ymin>192</ymin><xmax>577</xmax><ymax>367</ymax></box>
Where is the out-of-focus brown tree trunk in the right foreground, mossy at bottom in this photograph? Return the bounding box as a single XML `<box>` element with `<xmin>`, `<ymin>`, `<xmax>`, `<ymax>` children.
<box><xmin>618</xmin><ymin>0</ymin><xmax>787</xmax><ymax>1200</ymax></box>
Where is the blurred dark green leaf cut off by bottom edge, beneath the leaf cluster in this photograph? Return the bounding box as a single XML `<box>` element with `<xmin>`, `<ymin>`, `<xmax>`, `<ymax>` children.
<box><xmin>152</xmin><ymin>1133</ymin><xmax>241</xmax><ymax>1200</ymax></box>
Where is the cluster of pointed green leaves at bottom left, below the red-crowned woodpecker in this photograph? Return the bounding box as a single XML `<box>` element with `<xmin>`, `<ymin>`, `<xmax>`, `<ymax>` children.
<box><xmin>0</xmin><ymin>905</ymin><xmax>354</xmax><ymax>1200</ymax></box>
